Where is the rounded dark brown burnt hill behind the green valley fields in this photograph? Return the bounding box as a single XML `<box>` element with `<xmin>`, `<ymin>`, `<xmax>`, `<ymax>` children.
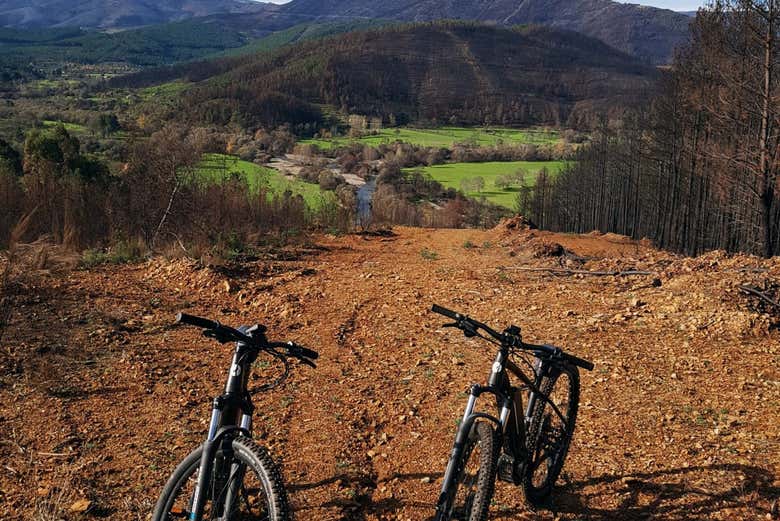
<box><xmin>171</xmin><ymin>22</ymin><xmax>657</xmax><ymax>128</ymax></box>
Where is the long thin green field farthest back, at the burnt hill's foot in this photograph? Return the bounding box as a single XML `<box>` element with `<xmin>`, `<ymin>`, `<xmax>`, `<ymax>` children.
<box><xmin>300</xmin><ymin>127</ymin><xmax>560</xmax><ymax>149</ymax></box>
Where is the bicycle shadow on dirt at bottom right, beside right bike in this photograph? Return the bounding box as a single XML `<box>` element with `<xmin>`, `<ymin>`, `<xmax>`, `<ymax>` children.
<box><xmin>495</xmin><ymin>463</ymin><xmax>780</xmax><ymax>521</ymax></box>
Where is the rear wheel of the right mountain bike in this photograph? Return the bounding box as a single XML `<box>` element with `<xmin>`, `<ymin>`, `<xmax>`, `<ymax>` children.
<box><xmin>523</xmin><ymin>364</ymin><xmax>580</xmax><ymax>506</ymax></box>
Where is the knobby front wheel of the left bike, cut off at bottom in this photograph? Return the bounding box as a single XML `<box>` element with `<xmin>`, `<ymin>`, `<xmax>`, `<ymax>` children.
<box><xmin>152</xmin><ymin>436</ymin><xmax>292</xmax><ymax>521</ymax></box>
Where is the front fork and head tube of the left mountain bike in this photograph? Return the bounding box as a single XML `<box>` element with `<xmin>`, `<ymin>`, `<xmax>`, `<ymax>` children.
<box><xmin>190</xmin><ymin>334</ymin><xmax>258</xmax><ymax>521</ymax></box>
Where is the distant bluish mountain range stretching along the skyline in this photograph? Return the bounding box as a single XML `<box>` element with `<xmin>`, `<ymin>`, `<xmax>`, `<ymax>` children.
<box><xmin>0</xmin><ymin>0</ymin><xmax>690</xmax><ymax>64</ymax></box>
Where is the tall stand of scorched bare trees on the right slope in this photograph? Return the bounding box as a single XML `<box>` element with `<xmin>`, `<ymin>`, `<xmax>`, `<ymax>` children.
<box><xmin>526</xmin><ymin>1</ymin><xmax>780</xmax><ymax>256</ymax></box>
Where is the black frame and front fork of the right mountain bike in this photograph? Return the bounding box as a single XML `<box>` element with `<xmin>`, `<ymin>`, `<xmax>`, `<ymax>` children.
<box><xmin>435</xmin><ymin>346</ymin><xmax>568</xmax><ymax>521</ymax></box>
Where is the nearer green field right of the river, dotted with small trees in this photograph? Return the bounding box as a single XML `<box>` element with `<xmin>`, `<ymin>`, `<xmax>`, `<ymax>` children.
<box><xmin>407</xmin><ymin>161</ymin><xmax>567</xmax><ymax>210</ymax></box>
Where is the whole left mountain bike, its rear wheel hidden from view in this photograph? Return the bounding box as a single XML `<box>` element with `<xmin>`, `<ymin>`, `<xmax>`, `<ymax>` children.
<box><xmin>152</xmin><ymin>313</ymin><xmax>318</xmax><ymax>521</ymax></box>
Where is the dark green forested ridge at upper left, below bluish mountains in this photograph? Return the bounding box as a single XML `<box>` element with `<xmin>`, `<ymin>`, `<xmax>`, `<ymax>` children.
<box><xmin>0</xmin><ymin>18</ymin><xmax>390</xmax><ymax>83</ymax></box>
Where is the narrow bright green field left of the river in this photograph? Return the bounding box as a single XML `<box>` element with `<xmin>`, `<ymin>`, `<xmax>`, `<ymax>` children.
<box><xmin>196</xmin><ymin>154</ymin><xmax>335</xmax><ymax>208</ymax></box>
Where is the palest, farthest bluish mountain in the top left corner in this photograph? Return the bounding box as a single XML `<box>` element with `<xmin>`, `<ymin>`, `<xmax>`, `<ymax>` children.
<box><xmin>0</xmin><ymin>0</ymin><xmax>276</xmax><ymax>29</ymax></box>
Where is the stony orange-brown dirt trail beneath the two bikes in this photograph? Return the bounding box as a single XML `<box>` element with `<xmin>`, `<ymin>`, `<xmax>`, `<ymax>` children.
<box><xmin>0</xmin><ymin>228</ymin><xmax>780</xmax><ymax>520</ymax></box>
